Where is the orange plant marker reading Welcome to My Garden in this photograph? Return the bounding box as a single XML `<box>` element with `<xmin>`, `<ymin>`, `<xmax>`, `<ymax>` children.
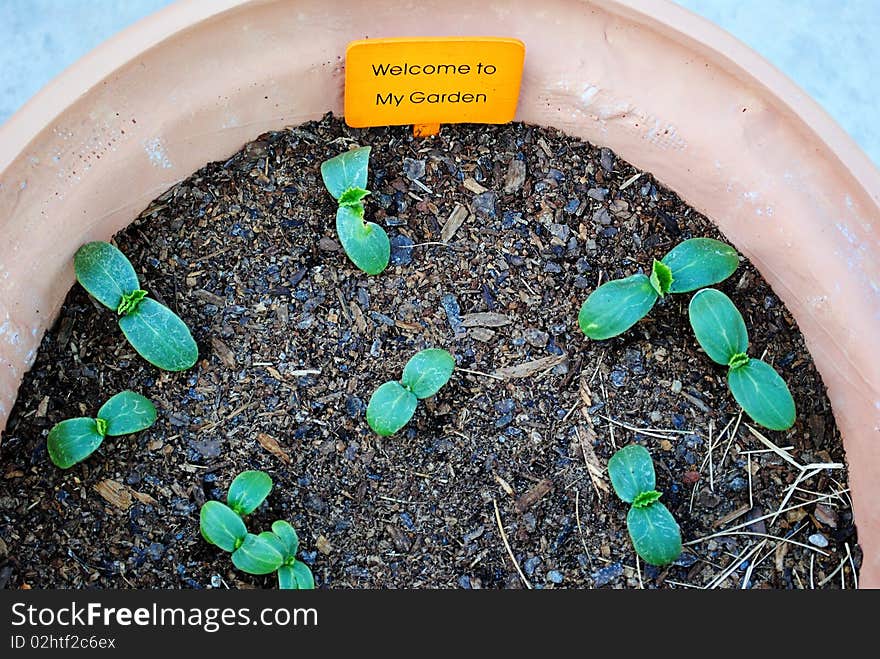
<box><xmin>345</xmin><ymin>37</ymin><xmax>525</xmax><ymax>137</ymax></box>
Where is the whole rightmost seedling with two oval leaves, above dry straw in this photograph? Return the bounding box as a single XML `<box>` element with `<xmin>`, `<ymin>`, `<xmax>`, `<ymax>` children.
<box><xmin>688</xmin><ymin>288</ymin><xmax>796</xmax><ymax>430</ymax></box>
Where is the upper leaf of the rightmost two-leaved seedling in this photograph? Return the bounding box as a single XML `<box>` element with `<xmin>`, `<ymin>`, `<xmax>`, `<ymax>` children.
<box><xmin>688</xmin><ymin>288</ymin><xmax>749</xmax><ymax>366</ymax></box>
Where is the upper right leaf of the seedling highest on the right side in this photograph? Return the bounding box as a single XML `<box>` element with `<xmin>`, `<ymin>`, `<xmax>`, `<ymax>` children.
<box><xmin>661</xmin><ymin>238</ymin><xmax>739</xmax><ymax>293</ymax></box>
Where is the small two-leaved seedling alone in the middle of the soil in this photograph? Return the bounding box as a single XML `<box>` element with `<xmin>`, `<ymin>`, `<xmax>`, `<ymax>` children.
<box><xmin>367</xmin><ymin>348</ymin><xmax>455</xmax><ymax>437</ymax></box>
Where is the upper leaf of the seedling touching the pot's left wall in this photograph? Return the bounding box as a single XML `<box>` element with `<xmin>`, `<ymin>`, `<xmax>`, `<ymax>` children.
<box><xmin>73</xmin><ymin>241</ymin><xmax>140</xmax><ymax>311</ymax></box>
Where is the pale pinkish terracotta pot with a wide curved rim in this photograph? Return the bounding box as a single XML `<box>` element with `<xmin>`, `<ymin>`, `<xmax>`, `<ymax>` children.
<box><xmin>0</xmin><ymin>0</ymin><xmax>880</xmax><ymax>587</ymax></box>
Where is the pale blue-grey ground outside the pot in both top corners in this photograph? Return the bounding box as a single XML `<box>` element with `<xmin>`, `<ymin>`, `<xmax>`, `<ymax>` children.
<box><xmin>0</xmin><ymin>0</ymin><xmax>880</xmax><ymax>165</ymax></box>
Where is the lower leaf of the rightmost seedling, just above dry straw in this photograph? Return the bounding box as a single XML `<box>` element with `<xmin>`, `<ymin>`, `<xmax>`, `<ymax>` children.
<box><xmin>727</xmin><ymin>359</ymin><xmax>797</xmax><ymax>430</ymax></box>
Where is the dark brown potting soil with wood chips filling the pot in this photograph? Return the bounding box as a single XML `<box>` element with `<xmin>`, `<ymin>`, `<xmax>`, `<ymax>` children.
<box><xmin>0</xmin><ymin>112</ymin><xmax>860</xmax><ymax>588</ymax></box>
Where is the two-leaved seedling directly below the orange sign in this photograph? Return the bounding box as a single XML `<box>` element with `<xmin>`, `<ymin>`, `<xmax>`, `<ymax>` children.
<box><xmin>321</xmin><ymin>146</ymin><xmax>391</xmax><ymax>275</ymax></box>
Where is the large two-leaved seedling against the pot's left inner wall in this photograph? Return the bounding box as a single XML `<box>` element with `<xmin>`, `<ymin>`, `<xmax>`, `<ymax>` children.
<box><xmin>74</xmin><ymin>241</ymin><xmax>199</xmax><ymax>371</ymax></box>
